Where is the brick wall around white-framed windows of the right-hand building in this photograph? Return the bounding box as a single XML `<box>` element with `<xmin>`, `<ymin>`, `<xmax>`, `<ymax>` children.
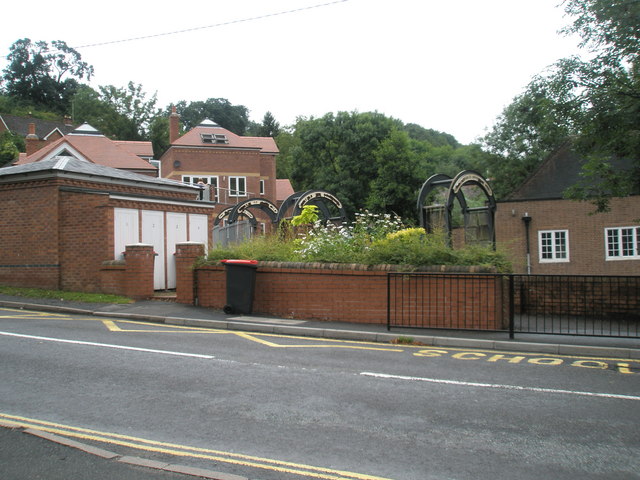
<box><xmin>496</xmin><ymin>196</ymin><xmax>640</xmax><ymax>275</ymax></box>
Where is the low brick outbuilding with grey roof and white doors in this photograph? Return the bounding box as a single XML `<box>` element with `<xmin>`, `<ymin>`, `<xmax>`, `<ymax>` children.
<box><xmin>0</xmin><ymin>158</ymin><xmax>214</xmax><ymax>297</ymax></box>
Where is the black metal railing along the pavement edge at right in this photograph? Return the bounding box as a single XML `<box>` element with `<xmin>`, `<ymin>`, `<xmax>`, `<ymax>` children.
<box><xmin>387</xmin><ymin>272</ymin><xmax>640</xmax><ymax>338</ymax></box>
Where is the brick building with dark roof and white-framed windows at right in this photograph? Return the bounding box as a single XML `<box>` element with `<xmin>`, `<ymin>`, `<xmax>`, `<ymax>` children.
<box><xmin>495</xmin><ymin>144</ymin><xmax>640</xmax><ymax>275</ymax></box>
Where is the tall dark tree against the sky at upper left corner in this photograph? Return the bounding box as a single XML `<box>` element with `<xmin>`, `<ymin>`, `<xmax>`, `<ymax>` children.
<box><xmin>2</xmin><ymin>38</ymin><xmax>93</xmax><ymax>114</ymax></box>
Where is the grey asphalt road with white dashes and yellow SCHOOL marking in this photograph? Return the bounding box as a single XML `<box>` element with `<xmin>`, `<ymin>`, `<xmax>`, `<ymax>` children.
<box><xmin>0</xmin><ymin>309</ymin><xmax>640</xmax><ymax>480</ymax></box>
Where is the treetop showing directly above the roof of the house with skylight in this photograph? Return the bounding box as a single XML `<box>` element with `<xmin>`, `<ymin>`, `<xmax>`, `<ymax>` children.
<box><xmin>171</xmin><ymin>98</ymin><xmax>249</xmax><ymax>135</ymax></box>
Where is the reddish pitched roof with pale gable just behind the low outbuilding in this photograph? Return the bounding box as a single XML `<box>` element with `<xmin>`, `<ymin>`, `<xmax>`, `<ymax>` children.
<box><xmin>15</xmin><ymin>124</ymin><xmax>156</xmax><ymax>172</ymax></box>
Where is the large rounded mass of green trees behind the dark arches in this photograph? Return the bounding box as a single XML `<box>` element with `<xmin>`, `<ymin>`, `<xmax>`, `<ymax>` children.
<box><xmin>276</xmin><ymin>112</ymin><xmax>486</xmax><ymax>223</ymax></box>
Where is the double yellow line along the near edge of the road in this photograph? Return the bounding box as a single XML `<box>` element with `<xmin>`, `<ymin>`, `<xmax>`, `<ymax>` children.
<box><xmin>0</xmin><ymin>413</ymin><xmax>390</xmax><ymax>480</ymax></box>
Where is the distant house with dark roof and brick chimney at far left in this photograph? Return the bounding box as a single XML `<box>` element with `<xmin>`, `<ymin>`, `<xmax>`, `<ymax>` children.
<box><xmin>0</xmin><ymin>114</ymin><xmax>74</xmax><ymax>155</ymax></box>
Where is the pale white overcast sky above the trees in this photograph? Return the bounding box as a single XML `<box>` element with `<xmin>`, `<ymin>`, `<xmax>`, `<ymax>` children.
<box><xmin>0</xmin><ymin>0</ymin><xmax>578</xmax><ymax>144</ymax></box>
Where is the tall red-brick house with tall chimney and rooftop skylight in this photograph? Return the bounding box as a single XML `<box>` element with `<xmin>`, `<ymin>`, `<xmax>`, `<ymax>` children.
<box><xmin>160</xmin><ymin>111</ymin><xmax>278</xmax><ymax>211</ymax></box>
